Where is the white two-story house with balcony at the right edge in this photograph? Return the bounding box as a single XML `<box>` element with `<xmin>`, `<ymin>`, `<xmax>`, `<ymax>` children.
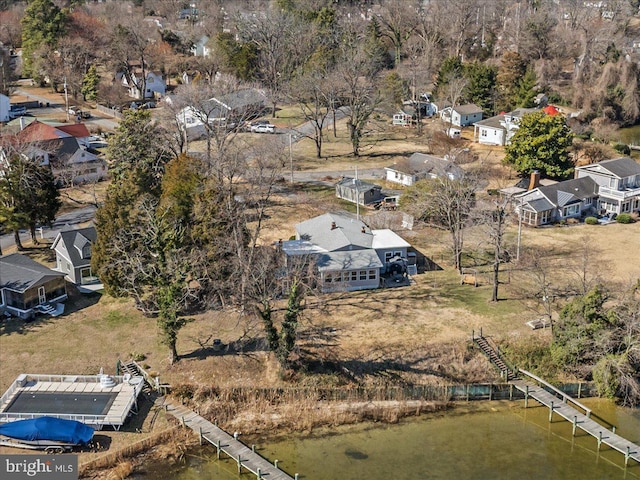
<box><xmin>575</xmin><ymin>157</ymin><xmax>640</xmax><ymax>214</ymax></box>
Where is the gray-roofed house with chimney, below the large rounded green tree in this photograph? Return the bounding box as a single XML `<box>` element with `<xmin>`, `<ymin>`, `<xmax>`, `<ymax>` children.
<box><xmin>514</xmin><ymin>177</ymin><xmax>598</xmax><ymax>226</ymax></box>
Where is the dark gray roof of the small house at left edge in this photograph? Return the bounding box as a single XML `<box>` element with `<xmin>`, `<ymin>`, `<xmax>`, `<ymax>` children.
<box><xmin>0</xmin><ymin>253</ymin><xmax>64</xmax><ymax>293</ymax></box>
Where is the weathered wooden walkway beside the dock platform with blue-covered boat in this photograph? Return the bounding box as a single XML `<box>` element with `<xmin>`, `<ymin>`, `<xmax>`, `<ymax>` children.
<box><xmin>163</xmin><ymin>403</ymin><xmax>298</xmax><ymax>480</ymax></box>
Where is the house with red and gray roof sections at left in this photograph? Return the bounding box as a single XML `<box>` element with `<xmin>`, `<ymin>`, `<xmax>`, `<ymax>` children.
<box><xmin>0</xmin><ymin>120</ymin><xmax>107</xmax><ymax>185</ymax></box>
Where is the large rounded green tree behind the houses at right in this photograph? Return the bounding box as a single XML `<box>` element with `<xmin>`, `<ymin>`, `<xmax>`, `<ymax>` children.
<box><xmin>503</xmin><ymin>111</ymin><xmax>574</xmax><ymax>179</ymax></box>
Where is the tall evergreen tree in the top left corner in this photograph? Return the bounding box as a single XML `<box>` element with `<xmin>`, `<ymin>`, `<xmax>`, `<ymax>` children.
<box><xmin>21</xmin><ymin>0</ymin><xmax>67</xmax><ymax>77</ymax></box>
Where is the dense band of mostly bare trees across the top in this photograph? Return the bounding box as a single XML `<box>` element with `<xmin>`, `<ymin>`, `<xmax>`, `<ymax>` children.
<box><xmin>0</xmin><ymin>0</ymin><xmax>640</xmax><ymax>137</ymax></box>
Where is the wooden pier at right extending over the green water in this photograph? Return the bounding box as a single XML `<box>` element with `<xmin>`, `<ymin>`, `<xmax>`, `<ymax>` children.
<box><xmin>510</xmin><ymin>379</ymin><xmax>640</xmax><ymax>465</ymax></box>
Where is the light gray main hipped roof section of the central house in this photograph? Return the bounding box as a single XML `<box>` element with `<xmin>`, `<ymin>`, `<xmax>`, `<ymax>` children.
<box><xmin>296</xmin><ymin>213</ymin><xmax>373</xmax><ymax>252</ymax></box>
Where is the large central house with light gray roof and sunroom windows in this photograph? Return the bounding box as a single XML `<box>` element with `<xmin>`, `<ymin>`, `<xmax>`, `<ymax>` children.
<box><xmin>279</xmin><ymin>213</ymin><xmax>410</xmax><ymax>292</ymax></box>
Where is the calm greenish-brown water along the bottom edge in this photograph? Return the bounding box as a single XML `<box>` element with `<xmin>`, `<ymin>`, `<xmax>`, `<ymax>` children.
<box><xmin>136</xmin><ymin>400</ymin><xmax>640</xmax><ymax>480</ymax></box>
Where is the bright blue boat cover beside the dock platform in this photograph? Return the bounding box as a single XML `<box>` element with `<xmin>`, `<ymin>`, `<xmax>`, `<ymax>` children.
<box><xmin>0</xmin><ymin>417</ymin><xmax>93</xmax><ymax>445</ymax></box>
